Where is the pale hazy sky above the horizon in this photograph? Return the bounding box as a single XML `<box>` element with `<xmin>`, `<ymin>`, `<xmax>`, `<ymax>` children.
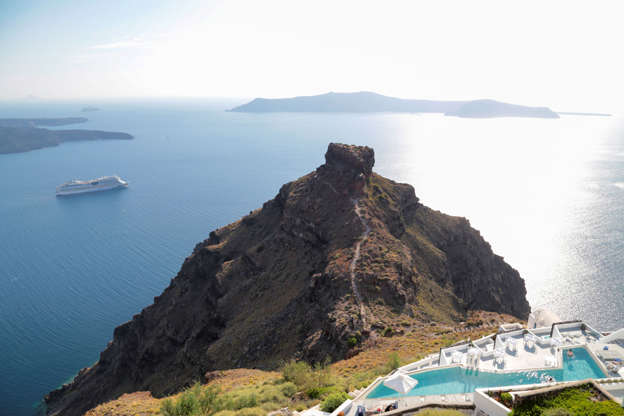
<box><xmin>0</xmin><ymin>0</ymin><xmax>624</xmax><ymax>112</ymax></box>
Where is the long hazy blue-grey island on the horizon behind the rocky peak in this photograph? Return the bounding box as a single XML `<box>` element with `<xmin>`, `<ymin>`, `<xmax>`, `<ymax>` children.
<box><xmin>230</xmin><ymin>91</ymin><xmax>559</xmax><ymax>118</ymax></box>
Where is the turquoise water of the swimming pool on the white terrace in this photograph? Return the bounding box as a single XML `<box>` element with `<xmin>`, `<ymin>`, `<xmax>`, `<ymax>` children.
<box><xmin>366</xmin><ymin>348</ymin><xmax>606</xmax><ymax>399</ymax></box>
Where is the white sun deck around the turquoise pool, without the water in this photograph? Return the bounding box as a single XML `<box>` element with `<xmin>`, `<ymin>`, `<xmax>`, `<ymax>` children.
<box><xmin>345</xmin><ymin>323</ymin><xmax>624</xmax><ymax>416</ymax></box>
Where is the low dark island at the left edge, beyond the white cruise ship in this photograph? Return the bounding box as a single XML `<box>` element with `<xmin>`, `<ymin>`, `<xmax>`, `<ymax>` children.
<box><xmin>0</xmin><ymin>117</ymin><xmax>133</xmax><ymax>154</ymax></box>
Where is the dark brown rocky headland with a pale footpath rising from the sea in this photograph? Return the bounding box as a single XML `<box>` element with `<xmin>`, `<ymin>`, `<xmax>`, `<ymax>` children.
<box><xmin>46</xmin><ymin>144</ymin><xmax>529</xmax><ymax>416</ymax></box>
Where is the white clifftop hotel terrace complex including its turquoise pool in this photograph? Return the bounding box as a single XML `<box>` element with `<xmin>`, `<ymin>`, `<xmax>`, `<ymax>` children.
<box><xmin>345</xmin><ymin>316</ymin><xmax>624</xmax><ymax>416</ymax></box>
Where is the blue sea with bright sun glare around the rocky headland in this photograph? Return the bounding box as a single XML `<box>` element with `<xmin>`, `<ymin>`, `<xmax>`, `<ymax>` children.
<box><xmin>0</xmin><ymin>99</ymin><xmax>624</xmax><ymax>416</ymax></box>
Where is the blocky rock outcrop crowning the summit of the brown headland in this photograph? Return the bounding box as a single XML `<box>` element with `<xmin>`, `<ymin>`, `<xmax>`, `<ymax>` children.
<box><xmin>325</xmin><ymin>143</ymin><xmax>375</xmax><ymax>176</ymax></box>
